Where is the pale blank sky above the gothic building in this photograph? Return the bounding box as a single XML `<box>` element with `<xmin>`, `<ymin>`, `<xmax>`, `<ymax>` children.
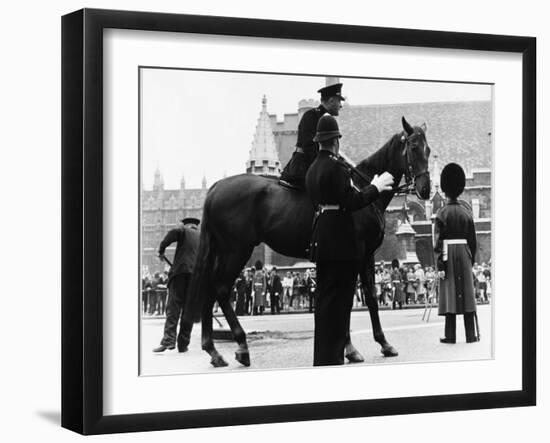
<box><xmin>141</xmin><ymin>68</ymin><xmax>491</xmax><ymax>189</ymax></box>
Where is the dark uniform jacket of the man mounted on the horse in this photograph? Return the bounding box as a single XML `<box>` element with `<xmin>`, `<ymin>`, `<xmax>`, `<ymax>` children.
<box><xmin>281</xmin><ymin>105</ymin><xmax>327</xmax><ymax>180</ymax></box>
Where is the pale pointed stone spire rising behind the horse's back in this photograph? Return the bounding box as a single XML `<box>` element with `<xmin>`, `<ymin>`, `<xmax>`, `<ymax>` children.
<box><xmin>246</xmin><ymin>95</ymin><xmax>281</xmax><ymax>176</ymax></box>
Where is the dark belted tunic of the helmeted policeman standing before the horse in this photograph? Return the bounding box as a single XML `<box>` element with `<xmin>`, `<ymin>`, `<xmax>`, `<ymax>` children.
<box><xmin>306</xmin><ymin>149</ymin><xmax>379</xmax><ymax>261</ymax></box>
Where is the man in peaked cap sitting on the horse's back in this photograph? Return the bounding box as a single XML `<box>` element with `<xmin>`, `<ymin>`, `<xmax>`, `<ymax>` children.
<box><xmin>281</xmin><ymin>83</ymin><xmax>345</xmax><ymax>188</ymax></box>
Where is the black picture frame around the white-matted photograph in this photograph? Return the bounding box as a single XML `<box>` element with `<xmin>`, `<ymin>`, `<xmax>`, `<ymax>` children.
<box><xmin>62</xmin><ymin>9</ymin><xmax>536</xmax><ymax>434</ymax></box>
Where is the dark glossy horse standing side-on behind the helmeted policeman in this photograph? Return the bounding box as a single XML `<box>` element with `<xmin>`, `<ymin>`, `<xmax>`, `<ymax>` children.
<box><xmin>185</xmin><ymin>118</ymin><xmax>430</xmax><ymax>367</ymax></box>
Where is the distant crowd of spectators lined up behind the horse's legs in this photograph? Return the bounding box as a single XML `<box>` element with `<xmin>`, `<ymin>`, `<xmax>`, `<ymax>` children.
<box><xmin>142</xmin><ymin>262</ymin><xmax>492</xmax><ymax>316</ymax></box>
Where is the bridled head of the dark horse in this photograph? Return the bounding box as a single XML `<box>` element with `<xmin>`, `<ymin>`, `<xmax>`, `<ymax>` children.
<box><xmin>401</xmin><ymin>117</ymin><xmax>430</xmax><ymax>200</ymax></box>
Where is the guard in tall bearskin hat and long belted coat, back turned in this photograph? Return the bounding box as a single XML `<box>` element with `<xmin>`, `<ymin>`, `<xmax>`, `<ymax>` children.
<box><xmin>434</xmin><ymin>163</ymin><xmax>479</xmax><ymax>343</ymax></box>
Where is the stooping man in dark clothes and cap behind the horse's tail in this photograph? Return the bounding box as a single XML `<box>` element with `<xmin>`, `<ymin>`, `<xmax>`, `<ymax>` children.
<box><xmin>153</xmin><ymin>217</ymin><xmax>200</xmax><ymax>352</ymax></box>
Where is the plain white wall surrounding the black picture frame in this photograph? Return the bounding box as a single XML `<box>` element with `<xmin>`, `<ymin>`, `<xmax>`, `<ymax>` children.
<box><xmin>0</xmin><ymin>0</ymin><xmax>550</xmax><ymax>443</ymax></box>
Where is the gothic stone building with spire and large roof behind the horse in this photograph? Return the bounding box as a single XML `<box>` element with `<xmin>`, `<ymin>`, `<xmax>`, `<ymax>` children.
<box><xmin>141</xmin><ymin>79</ymin><xmax>492</xmax><ymax>272</ymax></box>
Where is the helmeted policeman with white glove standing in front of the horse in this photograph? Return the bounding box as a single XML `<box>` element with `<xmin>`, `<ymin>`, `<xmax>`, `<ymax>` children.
<box><xmin>305</xmin><ymin>114</ymin><xmax>393</xmax><ymax>366</ymax></box>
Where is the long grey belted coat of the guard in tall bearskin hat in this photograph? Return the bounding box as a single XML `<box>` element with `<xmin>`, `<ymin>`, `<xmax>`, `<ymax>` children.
<box><xmin>434</xmin><ymin>201</ymin><xmax>477</xmax><ymax>315</ymax></box>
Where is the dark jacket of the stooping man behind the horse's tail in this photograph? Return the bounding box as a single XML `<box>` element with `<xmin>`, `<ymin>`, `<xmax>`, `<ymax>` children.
<box><xmin>159</xmin><ymin>226</ymin><xmax>199</xmax><ymax>283</ymax></box>
